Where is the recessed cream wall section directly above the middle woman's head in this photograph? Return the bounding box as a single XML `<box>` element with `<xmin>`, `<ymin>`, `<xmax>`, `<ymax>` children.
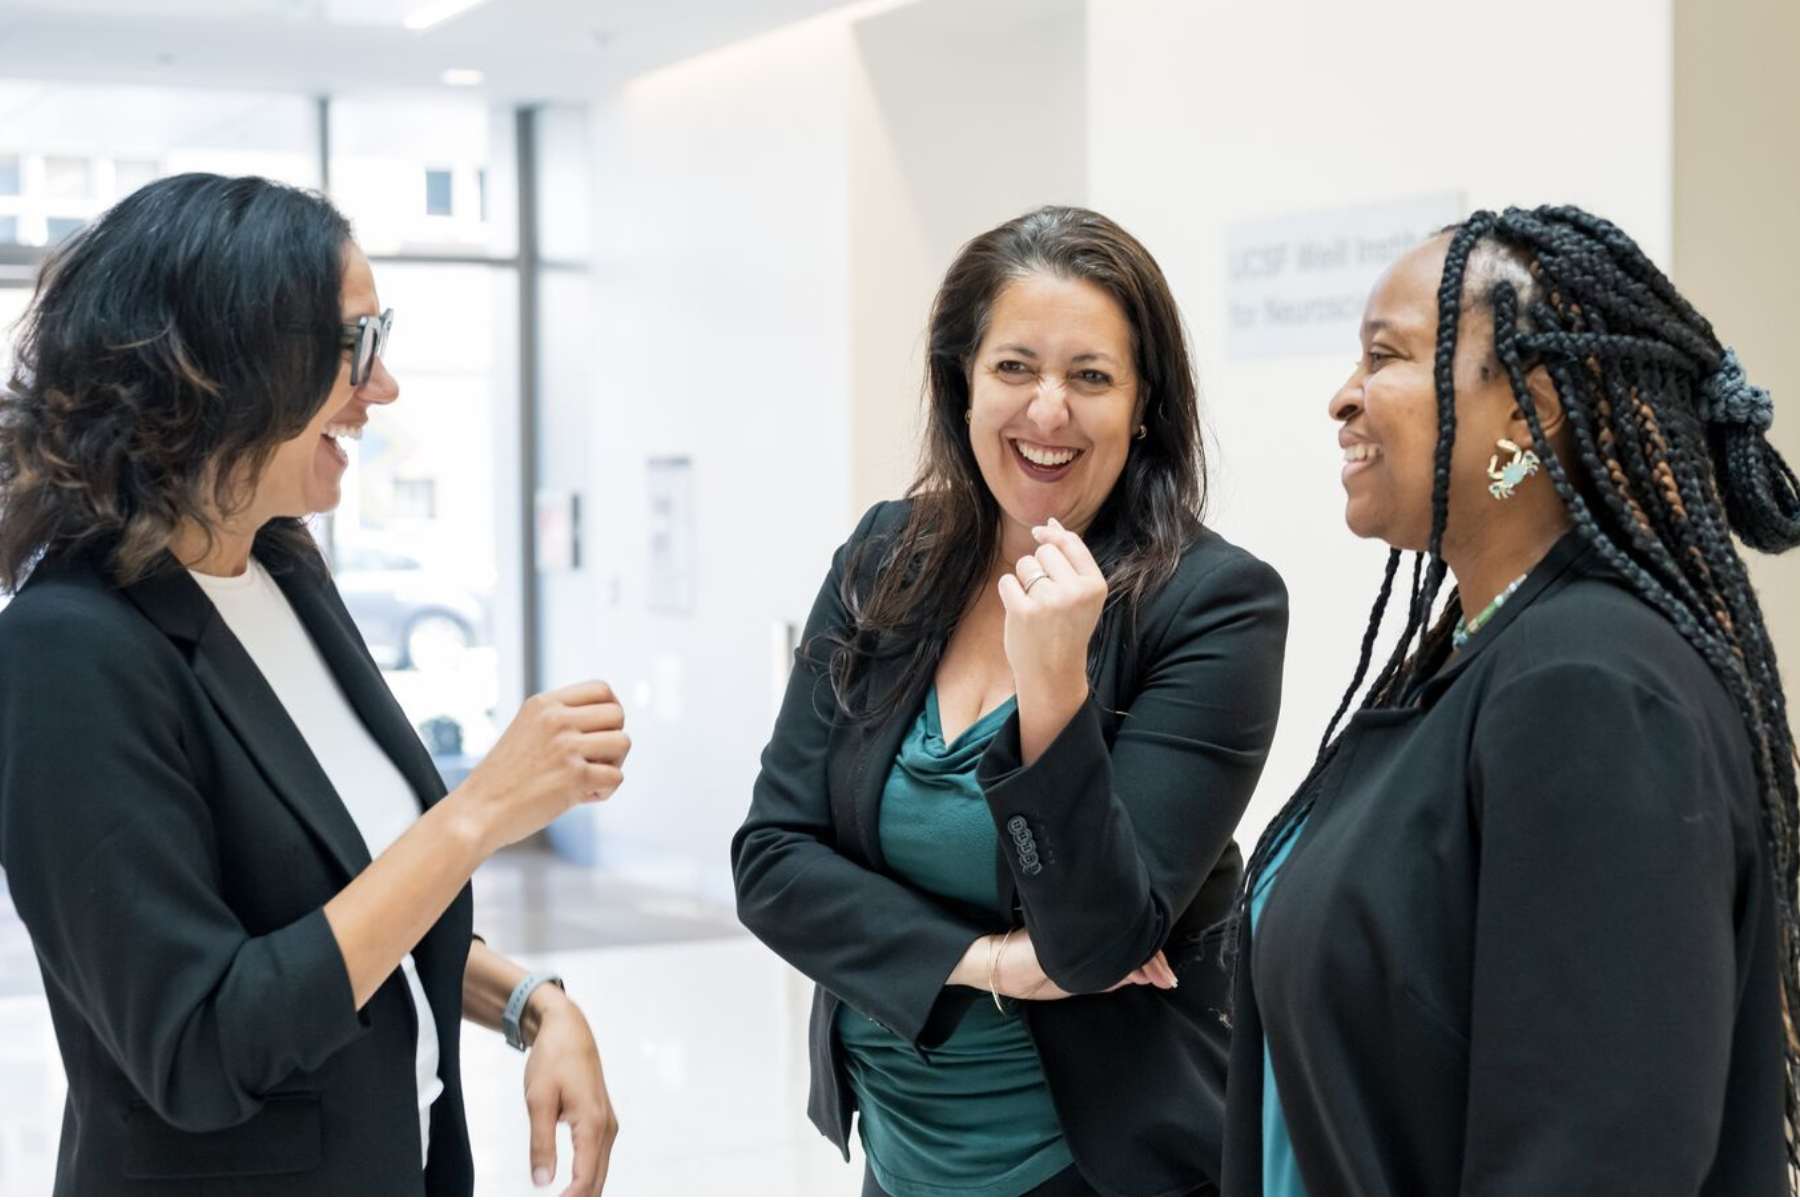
<box><xmin>850</xmin><ymin>0</ymin><xmax>1087</xmax><ymax>511</ymax></box>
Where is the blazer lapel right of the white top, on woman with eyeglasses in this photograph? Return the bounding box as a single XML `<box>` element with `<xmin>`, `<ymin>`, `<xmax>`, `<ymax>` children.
<box><xmin>274</xmin><ymin>570</ymin><xmax>445</xmax><ymax>808</ymax></box>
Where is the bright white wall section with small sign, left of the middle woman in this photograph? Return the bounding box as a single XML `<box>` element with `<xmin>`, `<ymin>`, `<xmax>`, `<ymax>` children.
<box><xmin>572</xmin><ymin>18</ymin><xmax>851</xmax><ymax>896</ymax></box>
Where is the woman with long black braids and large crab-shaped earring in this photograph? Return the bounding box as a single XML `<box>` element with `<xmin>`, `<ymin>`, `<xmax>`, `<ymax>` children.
<box><xmin>1224</xmin><ymin>209</ymin><xmax>1800</xmax><ymax>1195</ymax></box>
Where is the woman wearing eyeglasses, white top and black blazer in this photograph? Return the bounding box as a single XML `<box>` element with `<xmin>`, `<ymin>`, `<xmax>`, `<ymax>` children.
<box><xmin>0</xmin><ymin>175</ymin><xmax>630</xmax><ymax>1195</ymax></box>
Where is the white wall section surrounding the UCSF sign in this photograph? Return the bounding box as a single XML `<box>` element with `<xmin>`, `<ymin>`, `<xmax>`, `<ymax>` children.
<box><xmin>1089</xmin><ymin>0</ymin><xmax>1670</xmax><ymax>844</ymax></box>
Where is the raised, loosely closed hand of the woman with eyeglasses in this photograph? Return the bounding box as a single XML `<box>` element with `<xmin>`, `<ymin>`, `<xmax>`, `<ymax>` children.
<box><xmin>455</xmin><ymin>680</ymin><xmax>632</xmax><ymax>855</ymax></box>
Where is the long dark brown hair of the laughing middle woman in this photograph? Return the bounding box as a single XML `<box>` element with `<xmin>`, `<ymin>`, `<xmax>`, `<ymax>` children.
<box><xmin>824</xmin><ymin>207</ymin><xmax>1206</xmax><ymax>714</ymax></box>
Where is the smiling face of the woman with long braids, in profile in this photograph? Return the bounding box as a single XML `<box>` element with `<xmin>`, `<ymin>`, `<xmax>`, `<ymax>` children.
<box><xmin>1330</xmin><ymin>236</ymin><xmax>1530</xmax><ymax>551</ymax></box>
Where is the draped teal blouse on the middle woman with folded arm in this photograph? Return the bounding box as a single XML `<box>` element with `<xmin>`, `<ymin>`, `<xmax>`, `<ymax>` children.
<box><xmin>837</xmin><ymin>687</ymin><xmax>1073</xmax><ymax>1196</ymax></box>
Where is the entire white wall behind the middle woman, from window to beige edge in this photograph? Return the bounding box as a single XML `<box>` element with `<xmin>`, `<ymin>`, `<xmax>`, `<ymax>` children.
<box><xmin>545</xmin><ymin>0</ymin><xmax>1670</xmax><ymax>896</ymax></box>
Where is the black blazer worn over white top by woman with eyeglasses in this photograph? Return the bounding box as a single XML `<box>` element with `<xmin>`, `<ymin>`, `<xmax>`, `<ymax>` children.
<box><xmin>0</xmin><ymin>543</ymin><xmax>473</xmax><ymax>1195</ymax></box>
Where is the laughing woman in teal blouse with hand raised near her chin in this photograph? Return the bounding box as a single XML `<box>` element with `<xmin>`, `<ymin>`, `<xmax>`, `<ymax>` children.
<box><xmin>733</xmin><ymin>209</ymin><xmax>1287</xmax><ymax>1195</ymax></box>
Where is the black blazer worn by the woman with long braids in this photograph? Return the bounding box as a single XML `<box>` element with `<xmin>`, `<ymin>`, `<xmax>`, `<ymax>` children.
<box><xmin>1226</xmin><ymin>534</ymin><xmax>1787</xmax><ymax>1195</ymax></box>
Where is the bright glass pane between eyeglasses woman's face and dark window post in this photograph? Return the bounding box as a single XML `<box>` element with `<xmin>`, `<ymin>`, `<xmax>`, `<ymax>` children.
<box><xmin>331</xmin><ymin>261</ymin><xmax>518</xmax><ymax>773</ymax></box>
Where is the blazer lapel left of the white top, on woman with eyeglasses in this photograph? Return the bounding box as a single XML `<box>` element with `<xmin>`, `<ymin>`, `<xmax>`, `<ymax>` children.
<box><xmin>124</xmin><ymin>558</ymin><xmax>369</xmax><ymax>880</ymax></box>
